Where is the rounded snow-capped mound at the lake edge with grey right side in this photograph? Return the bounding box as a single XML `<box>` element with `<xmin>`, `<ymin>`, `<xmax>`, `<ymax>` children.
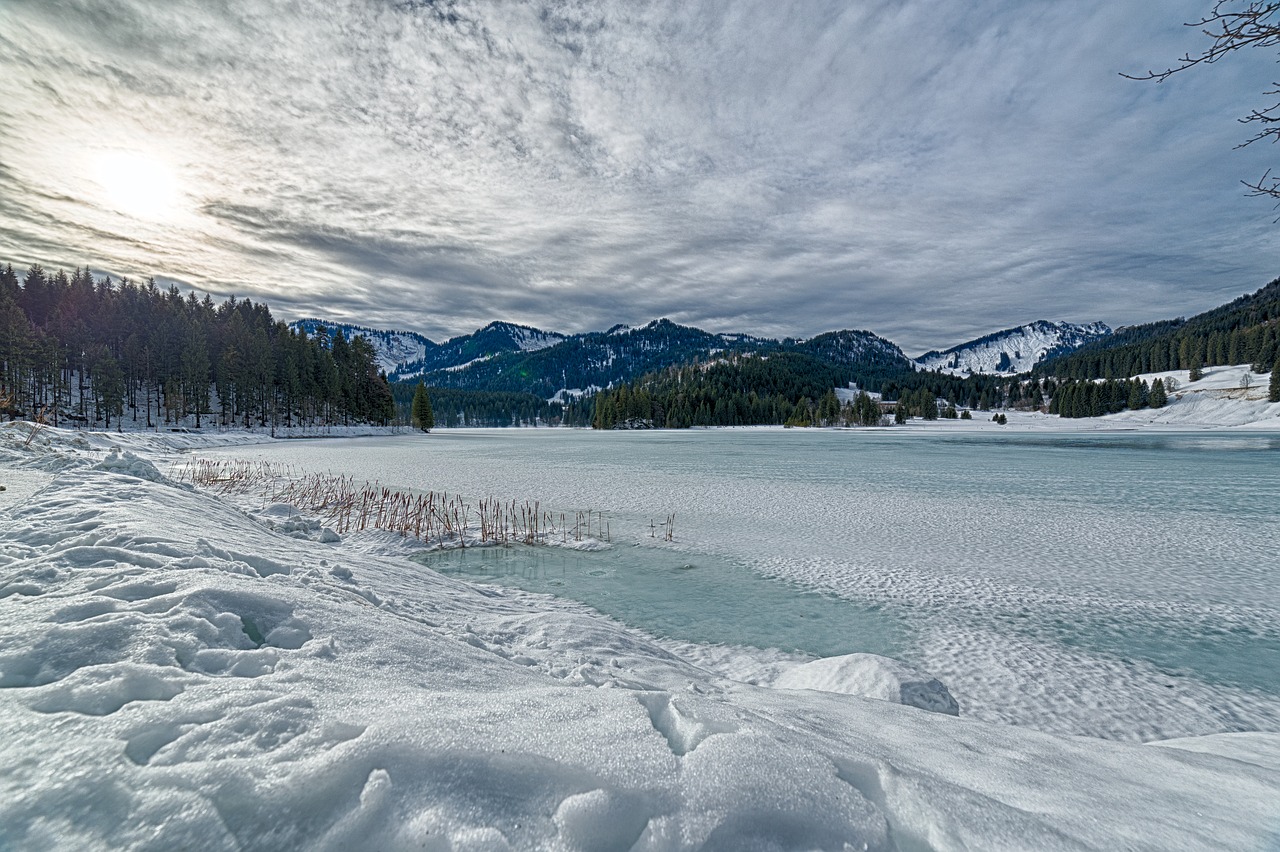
<box><xmin>773</xmin><ymin>654</ymin><xmax>960</xmax><ymax>716</ymax></box>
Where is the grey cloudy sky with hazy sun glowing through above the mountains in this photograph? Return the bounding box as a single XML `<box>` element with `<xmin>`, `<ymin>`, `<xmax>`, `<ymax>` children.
<box><xmin>0</xmin><ymin>0</ymin><xmax>1280</xmax><ymax>354</ymax></box>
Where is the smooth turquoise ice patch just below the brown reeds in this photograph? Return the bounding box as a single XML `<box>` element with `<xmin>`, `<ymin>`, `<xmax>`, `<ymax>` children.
<box><xmin>417</xmin><ymin>545</ymin><xmax>906</xmax><ymax>656</ymax></box>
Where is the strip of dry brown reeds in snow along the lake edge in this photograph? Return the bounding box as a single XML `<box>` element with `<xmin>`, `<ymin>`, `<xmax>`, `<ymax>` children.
<box><xmin>174</xmin><ymin>458</ymin><xmax>645</xmax><ymax>548</ymax></box>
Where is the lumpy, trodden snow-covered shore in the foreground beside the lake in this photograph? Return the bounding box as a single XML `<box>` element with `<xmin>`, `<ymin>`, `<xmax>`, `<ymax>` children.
<box><xmin>0</xmin><ymin>425</ymin><xmax>1280</xmax><ymax>849</ymax></box>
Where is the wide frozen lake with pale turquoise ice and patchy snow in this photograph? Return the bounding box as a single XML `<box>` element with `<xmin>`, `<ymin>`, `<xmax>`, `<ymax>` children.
<box><xmin>202</xmin><ymin>430</ymin><xmax>1280</xmax><ymax>739</ymax></box>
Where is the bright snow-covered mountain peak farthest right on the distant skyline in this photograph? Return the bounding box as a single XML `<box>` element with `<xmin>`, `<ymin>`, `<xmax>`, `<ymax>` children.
<box><xmin>915</xmin><ymin>320</ymin><xmax>1111</xmax><ymax>376</ymax></box>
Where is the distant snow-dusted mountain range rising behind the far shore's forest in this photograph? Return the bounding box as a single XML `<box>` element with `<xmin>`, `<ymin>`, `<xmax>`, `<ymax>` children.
<box><xmin>292</xmin><ymin>313</ymin><xmax>1111</xmax><ymax>400</ymax></box>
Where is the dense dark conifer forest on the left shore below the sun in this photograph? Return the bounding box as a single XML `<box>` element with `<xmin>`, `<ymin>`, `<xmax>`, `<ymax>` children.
<box><xmin>0</xmin><ymin>265</ymin><xmax>396</xmax><ymax>429</ymax></box>
